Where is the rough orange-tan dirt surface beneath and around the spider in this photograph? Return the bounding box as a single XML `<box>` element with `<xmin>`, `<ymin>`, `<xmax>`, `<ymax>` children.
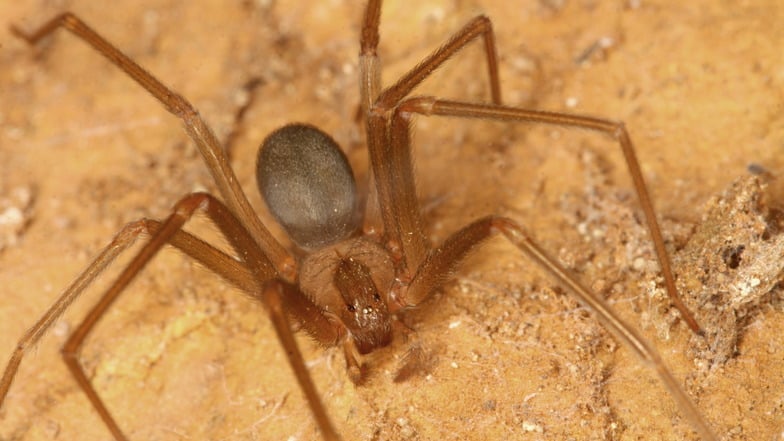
<box><xmin>0</xmin><ymin>0</ymin><xmax>784</xmax><ymax>440</ymax></box>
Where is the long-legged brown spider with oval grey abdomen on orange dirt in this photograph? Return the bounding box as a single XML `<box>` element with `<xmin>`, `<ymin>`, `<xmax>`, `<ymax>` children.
<box><xmin>0</xmin><ymin>1</ymin><xmax>715</xmax><ymax>439</ymax></box>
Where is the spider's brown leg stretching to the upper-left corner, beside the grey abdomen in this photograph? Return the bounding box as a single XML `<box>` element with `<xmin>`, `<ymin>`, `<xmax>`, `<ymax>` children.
<box><xmin>11</xmin><ymin>12</ymin><xmax>296</xmax><ymax>281</ymax></box>
